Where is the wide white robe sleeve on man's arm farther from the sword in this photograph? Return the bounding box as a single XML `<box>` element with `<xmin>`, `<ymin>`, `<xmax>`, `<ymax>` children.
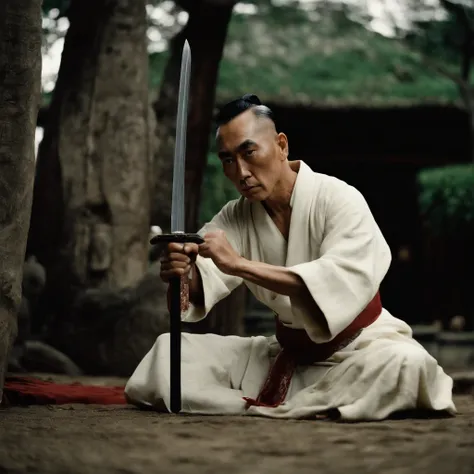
<box><xmin>290</xmin><ymin>181</ymin><xmax>391</xmax><ymax>343</ymax></box>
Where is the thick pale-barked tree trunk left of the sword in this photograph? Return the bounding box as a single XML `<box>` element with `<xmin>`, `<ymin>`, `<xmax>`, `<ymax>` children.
<box><xmin>28</xmin><ymin>0</ymin><xmax>151</xmax><ymax>343</ymax></box>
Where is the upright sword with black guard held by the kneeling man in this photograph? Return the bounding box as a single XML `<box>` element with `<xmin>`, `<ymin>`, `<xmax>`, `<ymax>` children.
<box><xmin>150</xmin><ymin>40</ymin><xmax>204</xmax><ymax>413</ymax></box>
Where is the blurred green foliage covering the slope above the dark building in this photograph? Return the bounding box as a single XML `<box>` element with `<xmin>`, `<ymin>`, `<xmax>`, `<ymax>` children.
<box><xmin>150</xmin><ymin>6</ymin><xmax>459</xmax><ymax>105</ymax></box>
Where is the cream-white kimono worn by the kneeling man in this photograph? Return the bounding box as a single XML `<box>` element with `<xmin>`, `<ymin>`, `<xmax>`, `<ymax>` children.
<box><xmin>125</xmin><ymin>162</ymin><xmax>456</xmax><ymax>421</ymax></box>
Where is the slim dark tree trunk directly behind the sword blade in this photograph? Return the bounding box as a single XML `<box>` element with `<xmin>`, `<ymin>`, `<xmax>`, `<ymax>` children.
<box><xmin>152</xmin><ymin>1</ymin><xmax>233</xmax><ymax>232</ymax></box>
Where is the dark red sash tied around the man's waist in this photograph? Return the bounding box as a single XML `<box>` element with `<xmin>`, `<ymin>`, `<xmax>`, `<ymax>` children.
<box><xmin>244</xmin><ymin>292</ymin><xmax>382</xmax><ymax>407</ymax></box>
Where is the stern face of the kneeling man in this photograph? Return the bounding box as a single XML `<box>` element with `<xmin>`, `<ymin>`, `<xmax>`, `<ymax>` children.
<box><xmin>217</xmin><ymin>109</ymin><xmax>288</xmax><ymax>201</ymax></box>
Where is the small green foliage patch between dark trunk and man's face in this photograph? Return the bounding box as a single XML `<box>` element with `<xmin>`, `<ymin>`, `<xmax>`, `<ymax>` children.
<box><xmin>199</xmin><ymin>153</ymin><xmax>240</xmax><ymax>224</ymax></box>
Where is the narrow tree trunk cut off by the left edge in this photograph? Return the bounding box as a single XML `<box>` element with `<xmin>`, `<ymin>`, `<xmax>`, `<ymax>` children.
<box><xmin>0</xmin><ymin>0</ymin><xmax>42</xmax><ymax>402</ymax></box>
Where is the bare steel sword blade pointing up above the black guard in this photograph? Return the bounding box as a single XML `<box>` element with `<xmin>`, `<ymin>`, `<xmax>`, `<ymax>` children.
<box><xmin>171</xmin><ymin>40</ymin><xmax>191</xmax><ymax>233</ymax></box>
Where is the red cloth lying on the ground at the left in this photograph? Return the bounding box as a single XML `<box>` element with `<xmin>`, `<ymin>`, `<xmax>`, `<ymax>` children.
<box><xmin>2</xmin><ymin>376</ymin><xmax>127</xmax><ymax>406</ymax></box>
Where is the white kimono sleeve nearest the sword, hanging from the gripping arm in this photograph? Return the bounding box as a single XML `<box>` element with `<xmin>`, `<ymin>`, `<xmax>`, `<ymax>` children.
<box><xmin>181</xmin><ymin>200</ymin><xmax>244</xmax><ymax>323</ymax></box>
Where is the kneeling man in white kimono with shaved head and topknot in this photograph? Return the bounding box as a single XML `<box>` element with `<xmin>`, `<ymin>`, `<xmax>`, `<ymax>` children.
<box><xmin>125</xmin><ymin>95</ymin><xmax>456</xmax><ymax>421</ymax></box>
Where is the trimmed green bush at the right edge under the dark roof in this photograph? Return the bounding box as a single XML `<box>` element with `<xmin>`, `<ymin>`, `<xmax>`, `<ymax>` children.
<box><xmin>418</xmin><ymin>164</ymin><xmax>474</xmax><ymax>235</ymax></box>
